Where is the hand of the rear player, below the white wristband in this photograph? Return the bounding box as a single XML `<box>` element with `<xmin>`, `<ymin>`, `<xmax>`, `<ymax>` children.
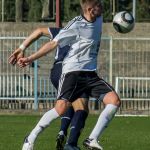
<box><xmin>8</xmin><ymin>48</ymin><xmax>24</xmax><ymax>65</ymax></box>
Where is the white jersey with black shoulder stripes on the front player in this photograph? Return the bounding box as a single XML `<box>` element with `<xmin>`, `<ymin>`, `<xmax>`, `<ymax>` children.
<box><xmin>54</xmin><ymin>16</ymin><xmax>102</xmax><ymax>73</ymax></box>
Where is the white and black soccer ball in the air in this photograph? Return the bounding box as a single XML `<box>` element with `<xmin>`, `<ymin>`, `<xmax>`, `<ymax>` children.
<box><xmin>113</xmin><ymin>11</ymin><xmax>135</xmax><ymax>33</ymax></box>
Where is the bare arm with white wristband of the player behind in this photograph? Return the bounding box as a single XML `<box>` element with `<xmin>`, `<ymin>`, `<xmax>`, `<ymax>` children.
<box><xmin>8</xmin><ymin>28</ymin><xmax>51</xmax><ymax>65</ymax></box>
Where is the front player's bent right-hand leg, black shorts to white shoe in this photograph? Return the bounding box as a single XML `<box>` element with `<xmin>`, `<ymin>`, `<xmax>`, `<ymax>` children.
<box><xmin>83</xmin><ymin>74</ymin><xmax>120</xmax><ymax>150</ymax></box>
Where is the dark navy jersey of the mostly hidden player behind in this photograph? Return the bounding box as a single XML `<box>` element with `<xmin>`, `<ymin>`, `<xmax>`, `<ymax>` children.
<box><xmin>48</xmin><ymin>28</ymin><xmax>69</xmax><ymax>63</ymax></box>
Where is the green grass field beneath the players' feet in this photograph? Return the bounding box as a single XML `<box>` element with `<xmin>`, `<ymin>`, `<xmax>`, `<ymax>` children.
<box><xmin>0</xmin><ymin>115</ymin><xmax>150</xmax><ymax>150</ymax></box>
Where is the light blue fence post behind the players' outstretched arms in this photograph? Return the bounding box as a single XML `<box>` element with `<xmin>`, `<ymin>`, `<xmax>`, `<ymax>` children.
<box><xmin>34</xmin><ymin>41</ymin><xmax>38</xmax><ymax>110</ymax></box>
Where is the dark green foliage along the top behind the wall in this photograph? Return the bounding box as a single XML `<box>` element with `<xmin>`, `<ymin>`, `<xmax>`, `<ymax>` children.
<box><xmin>0</xmin><ymin>0</ymin><xmax>150</xmax><ymax>22</ymax></box>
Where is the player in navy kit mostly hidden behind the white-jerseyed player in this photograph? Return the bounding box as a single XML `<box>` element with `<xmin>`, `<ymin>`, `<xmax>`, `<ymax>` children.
<box><xmin>9</xmin><ymin>28</ymin><xmax>88</xmax><ymax>150</ymax></box>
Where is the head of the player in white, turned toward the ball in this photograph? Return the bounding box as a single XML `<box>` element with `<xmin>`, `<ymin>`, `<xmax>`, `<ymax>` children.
<box><xmin>80</xmin><ymin>0</ymin><xmax>102</xmax><ymax>18</ymax></box>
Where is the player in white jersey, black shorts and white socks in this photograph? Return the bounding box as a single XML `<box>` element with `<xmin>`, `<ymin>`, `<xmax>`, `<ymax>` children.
<box><xmin>11</xmin><ymin>0</ymin><xmax>120</xmax><ymax>150</ymax></box>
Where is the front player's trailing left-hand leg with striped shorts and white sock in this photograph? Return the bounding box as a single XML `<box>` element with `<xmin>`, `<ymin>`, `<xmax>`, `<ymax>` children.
<box><xmin>23</xmin><ymin>72</ymin><xmax>86</xmax><ymax>150</ymax></box>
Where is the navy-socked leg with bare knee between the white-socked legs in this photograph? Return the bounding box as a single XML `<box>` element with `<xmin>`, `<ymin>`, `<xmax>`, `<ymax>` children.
<box><xmin>64</xmin><ymin>96</ymin><xmax>88</xmax><ymax>150</ymax></box>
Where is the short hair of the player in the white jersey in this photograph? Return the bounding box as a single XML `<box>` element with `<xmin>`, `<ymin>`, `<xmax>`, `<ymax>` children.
<box><xmin>80</xmin><ymin>0</ymin><xmax>101</xmax><ymax>10</ymax></box>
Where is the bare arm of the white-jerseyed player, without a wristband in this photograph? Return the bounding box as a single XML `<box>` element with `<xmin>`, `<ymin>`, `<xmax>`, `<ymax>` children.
<box><xmin>18</xmin><ymin>41</ymin><xmax>58</xmax><ymax>68</ymax></box>
